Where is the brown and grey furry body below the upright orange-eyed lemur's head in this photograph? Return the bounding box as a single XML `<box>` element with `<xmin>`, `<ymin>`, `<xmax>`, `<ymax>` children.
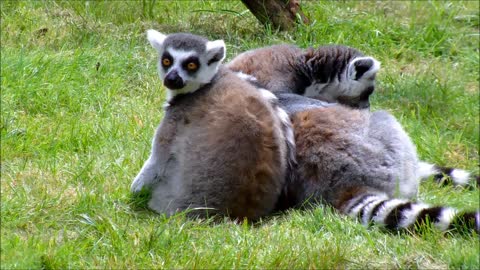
<box><xmin>132</xmin><ymin>66</ymin><xmax>287</xmax><ymax>219</ymax></box>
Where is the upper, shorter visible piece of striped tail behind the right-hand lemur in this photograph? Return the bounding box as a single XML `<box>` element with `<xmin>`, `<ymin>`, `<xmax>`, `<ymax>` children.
<box><xmin>418</xmin><ymin>162</ymin><xmax>480</xmax><ymax>187</ymax></box>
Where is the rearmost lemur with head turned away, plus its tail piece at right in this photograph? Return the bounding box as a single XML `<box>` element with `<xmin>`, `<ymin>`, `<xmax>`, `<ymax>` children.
<box><xmin>227</xmin><ymin>45</ymin><xmax>480</xmax><ymax>186</ymax></box>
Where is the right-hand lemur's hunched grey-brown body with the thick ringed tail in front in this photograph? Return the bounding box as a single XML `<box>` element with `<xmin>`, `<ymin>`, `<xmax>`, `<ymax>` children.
<box><xmin>278</xmin><ymin>94</ymin><xmax>480</xmax><ymax>232</ymax></box>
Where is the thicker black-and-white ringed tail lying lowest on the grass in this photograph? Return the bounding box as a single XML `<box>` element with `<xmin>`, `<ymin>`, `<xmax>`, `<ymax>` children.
<box><xmin>343</xmin><ymin>194</ymin><xmax>480</xmax><ymax>233</ymax></box>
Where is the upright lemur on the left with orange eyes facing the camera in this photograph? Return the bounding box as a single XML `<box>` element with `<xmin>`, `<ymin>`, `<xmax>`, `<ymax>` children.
<box><xmin>131</xmin><ymin>30</ymin><xmax>294</xmax><ymax>219</ymax></box>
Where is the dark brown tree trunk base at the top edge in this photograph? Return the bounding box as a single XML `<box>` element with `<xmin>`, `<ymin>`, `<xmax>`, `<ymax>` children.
<box><xmin>242</xmin><ymin>0</ymin><xmax>309</xmax><ymax>31</ymax></box>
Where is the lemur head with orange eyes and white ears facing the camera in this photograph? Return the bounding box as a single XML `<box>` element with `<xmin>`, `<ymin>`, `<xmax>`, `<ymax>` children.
<box><xmin>147</xmin><ymin>30</ymin><xmax>226</xmax><ymax>100</ymax></box>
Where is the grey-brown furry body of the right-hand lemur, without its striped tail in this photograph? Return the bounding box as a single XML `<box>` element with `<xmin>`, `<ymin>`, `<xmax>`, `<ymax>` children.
<box><xmin>279</xmin><ymin>94</ymin><xmax>419</xmax><ymax>208</ymax></box>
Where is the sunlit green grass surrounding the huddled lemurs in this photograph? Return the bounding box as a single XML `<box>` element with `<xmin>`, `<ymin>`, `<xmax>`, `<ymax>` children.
<box><xmin>0</xmin><ymin>0</ymin><xmax>480</xmax><ymax>269</ymax></box>
